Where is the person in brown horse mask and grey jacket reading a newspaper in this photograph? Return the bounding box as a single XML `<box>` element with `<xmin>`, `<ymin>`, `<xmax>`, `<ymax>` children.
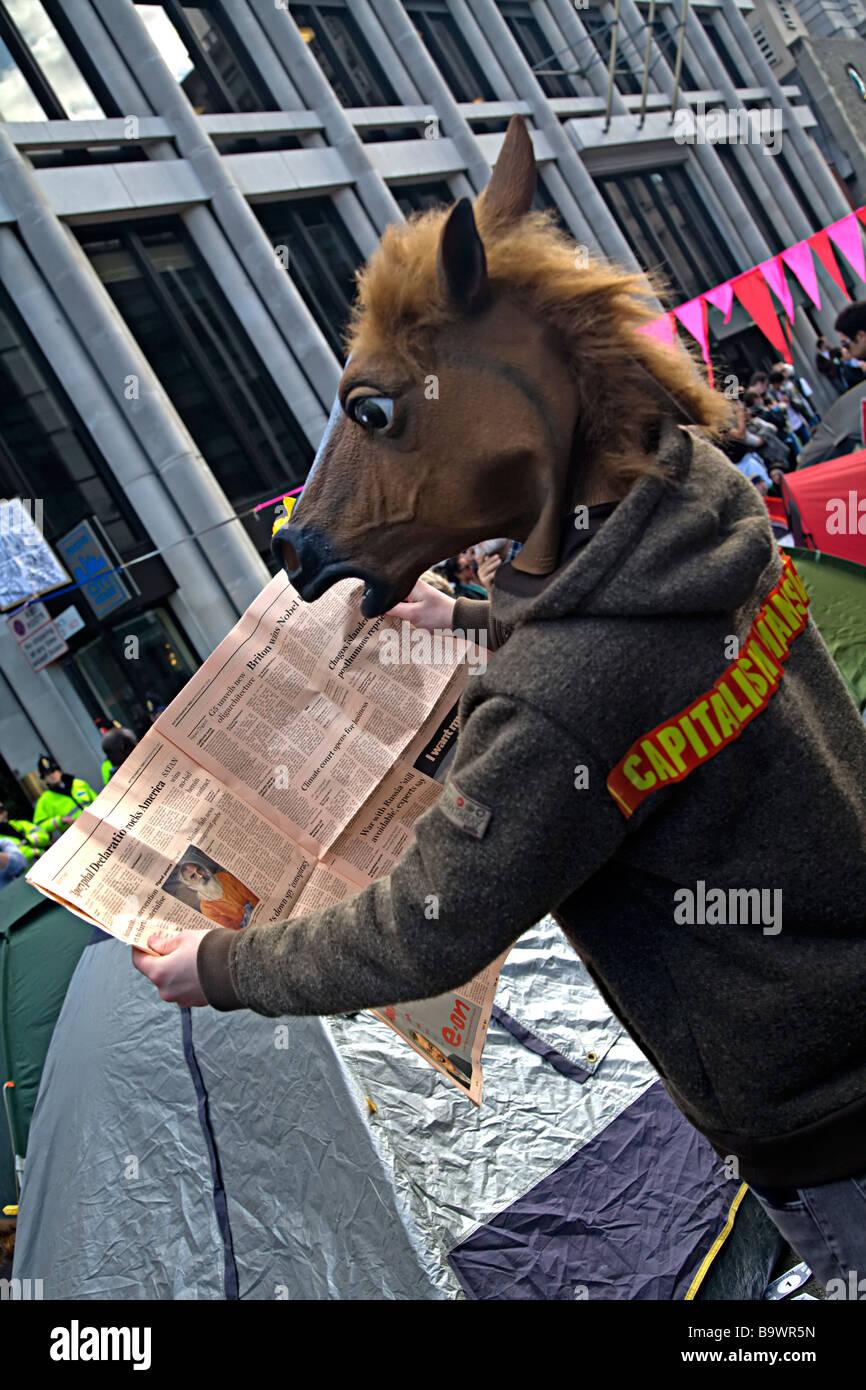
<box><xmin>136</xmin><ymin>118</ymin><xmax>866</xmax><ymax>1280</ymax></box>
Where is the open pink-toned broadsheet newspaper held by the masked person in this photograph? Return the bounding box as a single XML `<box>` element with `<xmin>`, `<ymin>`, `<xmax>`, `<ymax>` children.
<box><xmin>28</xmin><ymin>575</ymin><xmax>505</xmax><ymax>1104</ymax></box>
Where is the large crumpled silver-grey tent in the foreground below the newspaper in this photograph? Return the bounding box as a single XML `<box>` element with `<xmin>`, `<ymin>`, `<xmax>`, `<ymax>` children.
<box><xmin>14</xmin><ymin>919</ymin><xmax>774</xmax><ymax>1300</ymax></box>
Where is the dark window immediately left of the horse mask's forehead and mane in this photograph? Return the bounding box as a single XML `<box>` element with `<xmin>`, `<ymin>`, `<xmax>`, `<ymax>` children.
<box><xmin>253</xmin><ymin>197</ymin><xmax>361</xmax><ymax>361</ymax></box>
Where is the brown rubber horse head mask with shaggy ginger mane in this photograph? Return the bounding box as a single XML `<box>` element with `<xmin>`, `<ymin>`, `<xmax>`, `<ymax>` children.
<box><xmin>279</xmin><ymin>117</ymin><xmax>728</xmax><ymax>617</ymax></box>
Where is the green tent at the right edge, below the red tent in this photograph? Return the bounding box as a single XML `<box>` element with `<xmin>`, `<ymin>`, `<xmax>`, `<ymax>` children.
<box><xmin>787</xmin><ymin>548</ymin><xmax>866</xmax><ymax>709</ymax></box>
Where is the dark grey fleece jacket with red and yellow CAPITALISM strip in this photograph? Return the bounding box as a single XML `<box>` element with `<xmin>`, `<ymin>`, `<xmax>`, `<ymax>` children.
<box><xmin>199</xmin><ymin>424</ymin><xmax>866</xmax><ymax>1186</ymax></box>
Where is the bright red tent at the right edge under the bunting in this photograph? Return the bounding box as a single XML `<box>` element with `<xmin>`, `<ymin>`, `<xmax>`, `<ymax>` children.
<box><xmin>781</xmin><ymin>449</ymin><xmax>866</xmax><ymax>564</ymax></box>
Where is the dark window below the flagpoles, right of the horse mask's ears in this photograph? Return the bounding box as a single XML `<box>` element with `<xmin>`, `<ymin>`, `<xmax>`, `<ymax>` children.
<box><xmin>598</xmin><ymin>164</ymin><xmax>741</xmax><ymax>306</ymax></box>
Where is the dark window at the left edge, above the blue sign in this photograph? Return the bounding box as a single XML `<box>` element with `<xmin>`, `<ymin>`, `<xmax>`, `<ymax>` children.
<box><xmin>0</xmin><ymin>292</ymin><xmax>147</xmax><ymax>559</ymax></box>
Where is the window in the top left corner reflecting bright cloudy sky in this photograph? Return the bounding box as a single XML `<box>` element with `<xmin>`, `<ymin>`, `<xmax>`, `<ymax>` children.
<box><xmin>0</xmin><ymin>0</ymin><xmax>106</xmax><ymax>121</ymax></box>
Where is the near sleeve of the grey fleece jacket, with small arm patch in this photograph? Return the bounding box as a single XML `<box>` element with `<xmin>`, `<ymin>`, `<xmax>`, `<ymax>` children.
<box><xmin>197</xmin><ymin>695</ymin><xmax>626</xmax><ymax>1016</ymax></box>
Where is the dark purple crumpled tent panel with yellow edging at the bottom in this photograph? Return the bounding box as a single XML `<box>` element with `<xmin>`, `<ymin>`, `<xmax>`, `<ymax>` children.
<box><xmin>450</xmin><ymin>1081</ymin><xmax>781</xmax><ymax>1301</ymax></box>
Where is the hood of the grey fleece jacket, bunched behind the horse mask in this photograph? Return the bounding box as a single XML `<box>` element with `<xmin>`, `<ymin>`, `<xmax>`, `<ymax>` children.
<box><xmin>496</xmin><ymin>421</ymin><xmax>776</xmax><ymax>626</ymax></box>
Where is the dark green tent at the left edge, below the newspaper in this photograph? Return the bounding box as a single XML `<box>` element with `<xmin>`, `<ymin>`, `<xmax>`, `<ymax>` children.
<box><xmin>0</xmin><ymin>878</ymin><xmax>93</xmax><ymax>1208</ymax></box>
